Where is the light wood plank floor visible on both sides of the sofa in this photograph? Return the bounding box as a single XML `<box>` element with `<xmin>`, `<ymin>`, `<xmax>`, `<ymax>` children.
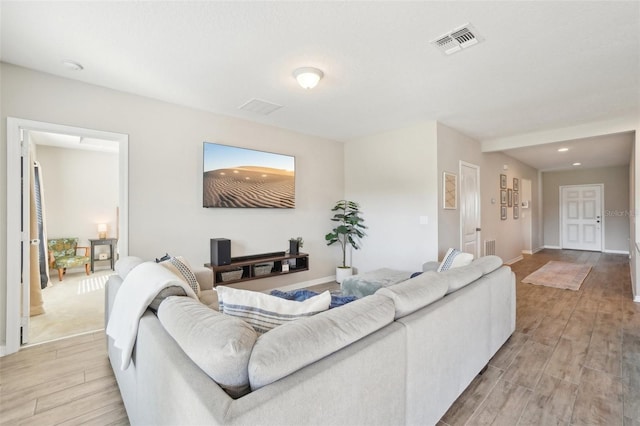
<box><xmin>0</xmin><ymin>250</ymin><xmax>640</xmax><ymax>426</ymax></box>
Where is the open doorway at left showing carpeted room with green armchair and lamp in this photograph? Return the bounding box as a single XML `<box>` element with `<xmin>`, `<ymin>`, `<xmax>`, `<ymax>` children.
<box><xmin>23</xmin><ymin>131</ymin><xmax>119</xmax><ymax>344</ymax></box>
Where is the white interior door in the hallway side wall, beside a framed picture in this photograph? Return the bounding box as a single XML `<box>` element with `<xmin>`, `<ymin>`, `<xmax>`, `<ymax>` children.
<box><xmin>460</xmin><ymin>161</ymin><xmax>480</xmax><ymax>258</ymax></box>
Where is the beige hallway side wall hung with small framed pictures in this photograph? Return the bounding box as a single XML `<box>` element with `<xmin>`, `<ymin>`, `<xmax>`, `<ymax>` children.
<box><xmin>438</xmin><ymin>123</ymin><xmax>540</xmax><ymax>262</ymax></box>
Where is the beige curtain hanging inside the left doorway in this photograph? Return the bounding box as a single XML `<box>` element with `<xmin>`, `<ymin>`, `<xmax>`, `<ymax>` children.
<box><xmin>29</xmin><ymin>161</ymin><xmax>49</xmax><ymax>316</ymax></box>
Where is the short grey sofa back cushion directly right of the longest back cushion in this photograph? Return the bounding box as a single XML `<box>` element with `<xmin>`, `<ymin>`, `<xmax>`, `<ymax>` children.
<box><xmin>376</xmin><ymin>271</ymin><xmax>449</xmax><ymax>319</ymax></box>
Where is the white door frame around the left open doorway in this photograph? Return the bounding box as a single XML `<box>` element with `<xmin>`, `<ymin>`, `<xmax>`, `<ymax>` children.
<box><xmin>0</xmin><ymin>117</ymin><xmax>129</xmax><ymax>356</ymax></box>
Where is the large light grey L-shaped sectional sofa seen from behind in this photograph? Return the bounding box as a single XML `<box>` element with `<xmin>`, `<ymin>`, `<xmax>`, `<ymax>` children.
<box><xmin>105</xmin><ymin>256</ymin><xmax>516</xmax><ymax>426</ymax></box>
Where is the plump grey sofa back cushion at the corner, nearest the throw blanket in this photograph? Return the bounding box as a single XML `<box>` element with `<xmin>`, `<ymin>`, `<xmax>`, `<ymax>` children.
<box><xmin>158</xmin><ymin>296</ymin><xmax>258</xmax><ymax>398</ymax></box>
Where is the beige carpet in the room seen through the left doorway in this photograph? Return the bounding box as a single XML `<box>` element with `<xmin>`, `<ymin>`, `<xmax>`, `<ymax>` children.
<box><xmin>28</xmin><ymin>269</ymin><xmax>114</xmax><ymax>344</ymax></box>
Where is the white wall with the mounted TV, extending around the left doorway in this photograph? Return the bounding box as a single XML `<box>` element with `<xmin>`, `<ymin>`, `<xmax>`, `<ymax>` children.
<box><xmin>0</xmin><ymin>63</ymin><xmax>344</xmax><ymax>340</ymax></box>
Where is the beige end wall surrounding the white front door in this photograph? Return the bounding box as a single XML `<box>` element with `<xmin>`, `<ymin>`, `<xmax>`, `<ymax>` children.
<box><xmin>542</xmin><ymin>166</ymin><xmax>630</xmax><ymax>253</ymax></box>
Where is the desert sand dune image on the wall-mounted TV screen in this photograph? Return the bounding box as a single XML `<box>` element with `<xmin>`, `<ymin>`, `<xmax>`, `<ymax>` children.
<box><xmin>202</xmin><ymin>142</ymin><xmax>295</xmax><ymax>209</ymax></box>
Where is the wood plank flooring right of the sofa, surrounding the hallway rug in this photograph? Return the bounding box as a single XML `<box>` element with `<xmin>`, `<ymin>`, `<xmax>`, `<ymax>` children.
<box><xmin>439</xmin><ymin>250</ymin><xmax>640</xmax><ymax>426</ymax></box>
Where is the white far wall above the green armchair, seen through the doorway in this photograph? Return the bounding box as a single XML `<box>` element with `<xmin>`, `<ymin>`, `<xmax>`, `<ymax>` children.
<box><xmin>36</xmin><ymin>145</ymin><xmax>118</xmax><ymax>251</ymax></box>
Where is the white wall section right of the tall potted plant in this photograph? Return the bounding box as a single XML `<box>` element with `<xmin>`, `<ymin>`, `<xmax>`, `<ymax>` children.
<box><xmin>344</xmin><ymin>122</ymin><xmax>438</xmax><ymax>272</ymax></box>
